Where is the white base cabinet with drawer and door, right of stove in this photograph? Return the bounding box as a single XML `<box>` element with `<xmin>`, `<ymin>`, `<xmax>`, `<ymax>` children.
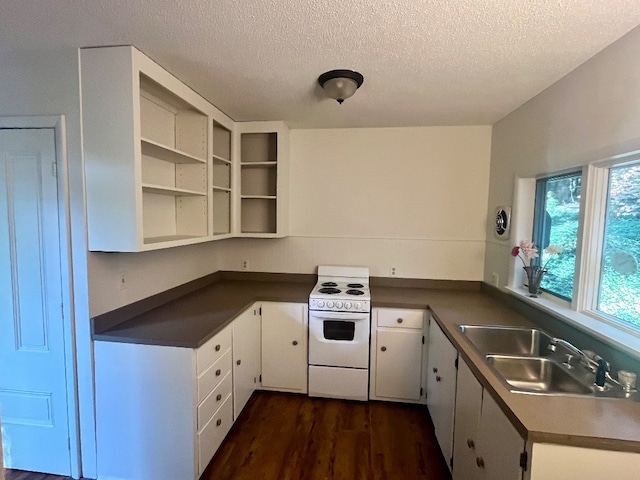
<box><xmin>369</xmin><ymin>308</ymin><xmax>427</xmax><ymax>403</ymax></box>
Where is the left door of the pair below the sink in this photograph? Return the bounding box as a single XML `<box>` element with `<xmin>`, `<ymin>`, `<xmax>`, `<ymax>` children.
<box><xmin>453</xmin><ymin>361</ymin><xmax>482</xmax><ymax>480</ymax></box>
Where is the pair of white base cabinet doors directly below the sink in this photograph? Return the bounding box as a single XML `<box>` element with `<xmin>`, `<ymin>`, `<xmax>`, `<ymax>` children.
<box><xmin>453</xmin><ymin>361</ymin><xmax>525</xmax><ymax>480</ymax></box>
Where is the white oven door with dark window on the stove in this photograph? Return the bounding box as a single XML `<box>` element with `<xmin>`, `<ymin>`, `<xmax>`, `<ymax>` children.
<box><xmin>309</xmin><ymin>310</ymin><xmax>371</xmax><ymax>368</ymax></box>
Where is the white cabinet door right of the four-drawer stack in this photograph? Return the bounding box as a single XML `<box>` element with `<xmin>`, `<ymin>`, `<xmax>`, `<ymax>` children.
<box><xmin>233</xmin><ymin>305</ymin><xmax>260</xmax><ymax>420</ymax></box>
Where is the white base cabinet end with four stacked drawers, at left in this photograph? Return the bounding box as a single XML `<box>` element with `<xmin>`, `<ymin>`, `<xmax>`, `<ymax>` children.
<box><xmin>95</xmin><ymin>327</ymin><xmax>233</xmax><ymax>480</ymax></box>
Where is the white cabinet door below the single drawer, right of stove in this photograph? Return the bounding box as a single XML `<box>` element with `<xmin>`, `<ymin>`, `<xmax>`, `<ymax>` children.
<box><xmin>376</xmin><ymin>328</ymin><xmax>422</xmax><ymax>402</ymax></box>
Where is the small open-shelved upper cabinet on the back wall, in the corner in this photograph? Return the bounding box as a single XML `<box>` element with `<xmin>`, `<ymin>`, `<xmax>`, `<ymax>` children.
<box><xmin>235</xmin><ymin>122</ymin><xmax>289</xmax><ymax>237</ymax></box>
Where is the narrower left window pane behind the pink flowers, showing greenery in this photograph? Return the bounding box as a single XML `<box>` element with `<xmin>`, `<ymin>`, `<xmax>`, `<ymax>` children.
<box><xmin>533</xmin><ymin>172</ymin><xmax>584</xmax><ymax>300</ymax></box>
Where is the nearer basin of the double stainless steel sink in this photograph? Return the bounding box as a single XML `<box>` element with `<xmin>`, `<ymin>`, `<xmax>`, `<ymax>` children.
<box><xmin>486</xmin><ymin>355</ymin><xmax>595</xmax><ymax>395</ymax></box>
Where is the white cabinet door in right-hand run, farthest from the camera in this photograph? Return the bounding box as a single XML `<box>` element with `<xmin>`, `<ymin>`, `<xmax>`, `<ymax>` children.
<box><xmin>427</xmin><ymin>319</ymin><xmax>458</xmax><ymax>465</ymax></box>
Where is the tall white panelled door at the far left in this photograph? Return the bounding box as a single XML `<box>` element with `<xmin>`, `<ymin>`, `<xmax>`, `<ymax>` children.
<box><xmin>0</xmin><ymin>129</ymin><xmax>71</xmax><ymax>475</ymax></box>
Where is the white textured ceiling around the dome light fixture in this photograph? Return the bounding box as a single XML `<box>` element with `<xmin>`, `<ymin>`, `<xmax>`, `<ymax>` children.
<box><xmin>0</xmin><ymin>0</ymin><xmax>640</xmax><ymax>128</ymax></box>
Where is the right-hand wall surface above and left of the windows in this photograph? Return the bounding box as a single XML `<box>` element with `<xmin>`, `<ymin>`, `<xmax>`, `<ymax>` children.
<box><xmin>484</xmin><ymin>28</ymin><xmax>640</xmax><ymax>285</ymax></box>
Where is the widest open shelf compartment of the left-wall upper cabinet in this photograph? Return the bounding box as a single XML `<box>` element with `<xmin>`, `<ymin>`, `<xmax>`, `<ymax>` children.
<box><xmin>139</xmin><ymin>73</ymin><xmax>209</xmax><ymax>248</ymax></box>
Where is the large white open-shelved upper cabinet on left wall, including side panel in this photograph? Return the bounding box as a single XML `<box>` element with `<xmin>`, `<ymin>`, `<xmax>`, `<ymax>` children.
<box><xmin>81</xmin><ymin>46</ymin><xmax>234</xmax><ymax>252</ymax></box>
